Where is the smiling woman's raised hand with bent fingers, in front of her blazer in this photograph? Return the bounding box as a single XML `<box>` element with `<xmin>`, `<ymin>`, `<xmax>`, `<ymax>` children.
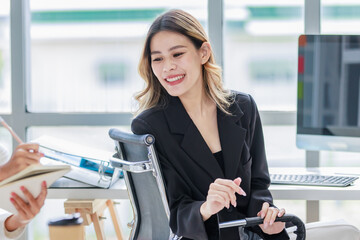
<box><xmin>200</xmin><ymin>178</ymin><xmax>246</xmax><ymax>221</ymax></box>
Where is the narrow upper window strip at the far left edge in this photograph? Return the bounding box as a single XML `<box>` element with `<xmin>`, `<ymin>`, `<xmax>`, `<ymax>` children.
<box><xmin>0</xmin><ymin>1</ymin><xmax>11</xmax><ymax>113</ymax></box>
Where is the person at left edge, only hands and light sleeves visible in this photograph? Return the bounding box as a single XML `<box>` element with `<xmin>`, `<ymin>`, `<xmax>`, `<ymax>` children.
<box><xmin>0</xmin><ymin>143</ymin><xmax>47</xmax><ymax>239</ymax></box>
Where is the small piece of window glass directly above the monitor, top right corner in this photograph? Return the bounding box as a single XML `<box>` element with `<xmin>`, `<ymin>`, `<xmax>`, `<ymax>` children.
<box><xmin>321</xmin><ymin>0</ymin><xmax>360</xmax><ymax>34</ymax></box>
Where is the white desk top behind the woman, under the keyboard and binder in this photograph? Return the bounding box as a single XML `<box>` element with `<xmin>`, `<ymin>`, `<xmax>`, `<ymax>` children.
<box><xmin>48</xmin><ymin>168</ymin><xmax>360</xmax><ymax>200</ymax></box>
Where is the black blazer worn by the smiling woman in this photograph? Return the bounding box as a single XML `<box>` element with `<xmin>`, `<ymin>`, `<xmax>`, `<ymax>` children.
<box><xmin>131</xmin><ymin>93</ymin><xmax>287</xmax><ymax>239</ymax></box>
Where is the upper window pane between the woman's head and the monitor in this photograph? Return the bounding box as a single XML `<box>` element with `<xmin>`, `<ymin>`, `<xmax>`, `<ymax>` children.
<box><xmin>224</xmin><ymin>0</ymin><xmax>304</xmax><ymax>110</ymax></box>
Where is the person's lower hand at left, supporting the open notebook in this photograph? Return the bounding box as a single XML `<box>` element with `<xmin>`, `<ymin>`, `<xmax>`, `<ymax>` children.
<box><xmin>5</xmin><ymin>181</ymin><xmax>47</xmax><ymax>232</ymax></box>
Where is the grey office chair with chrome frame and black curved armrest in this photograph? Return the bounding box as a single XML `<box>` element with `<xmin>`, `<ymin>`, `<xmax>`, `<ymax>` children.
<box><xmin>109</xmin><ymin>128</ymin><xmax>306</xmax><ymax>240</ymax></box>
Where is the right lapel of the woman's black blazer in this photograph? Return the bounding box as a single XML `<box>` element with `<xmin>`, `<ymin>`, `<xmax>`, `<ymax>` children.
<box><xmin>218</xmin><ymin>102</ymin><xmax>246</xmax><ymax>180</ymax></box>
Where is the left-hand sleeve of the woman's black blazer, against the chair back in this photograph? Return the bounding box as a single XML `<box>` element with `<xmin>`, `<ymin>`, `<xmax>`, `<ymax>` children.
<box><xmin>131</xmin><ymin>118</ymin><xmax>219</xmax><ymax>239</ymax></box>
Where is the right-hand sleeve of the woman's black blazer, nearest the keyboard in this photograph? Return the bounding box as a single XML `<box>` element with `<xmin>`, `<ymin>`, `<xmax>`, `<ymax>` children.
<box><xmin>247</xmin><ymin>95</ymin><xmax>289</xmax><ymax>240</ymax></box>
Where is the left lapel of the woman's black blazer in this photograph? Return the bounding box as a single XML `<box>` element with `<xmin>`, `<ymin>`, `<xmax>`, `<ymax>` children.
<box><xmin>164</xmin><ymin>97</ymin><xmax>224</xmax><ymax>179</ymax></box>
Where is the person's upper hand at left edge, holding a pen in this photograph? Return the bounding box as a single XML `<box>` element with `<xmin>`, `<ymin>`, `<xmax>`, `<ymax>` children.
<box><xmin>0</xmin><ymin>143</ymin><xmax>44</xmax><ymax>181</ymax></box>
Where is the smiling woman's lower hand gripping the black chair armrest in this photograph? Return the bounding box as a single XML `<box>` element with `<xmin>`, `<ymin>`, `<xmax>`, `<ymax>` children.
<box><xmin>257</xmin><ymin>202</ymin><xmax>285</xmax><ymax>235</ymax></box>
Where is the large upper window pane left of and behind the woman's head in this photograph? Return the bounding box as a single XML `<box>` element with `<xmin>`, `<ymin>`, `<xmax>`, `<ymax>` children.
<box><xmin>28</xmin><ymin>0</ymin><xmax>207</xmax><ymax>112</ymax></box>
